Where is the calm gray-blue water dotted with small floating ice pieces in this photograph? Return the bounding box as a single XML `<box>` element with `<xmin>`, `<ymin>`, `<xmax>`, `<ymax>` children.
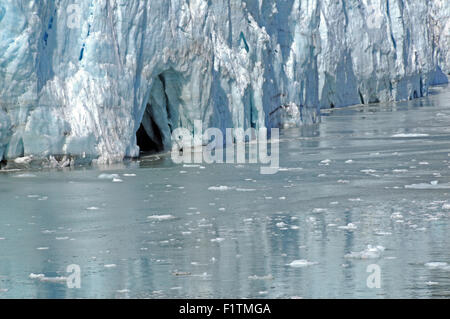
<box><xmin>0</xmin><ymin>87</ymin><xmax>450</xmax><ymax>298</ymax></box>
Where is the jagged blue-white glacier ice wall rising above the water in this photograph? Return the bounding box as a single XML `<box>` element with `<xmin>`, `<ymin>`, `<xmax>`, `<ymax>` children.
<box><xmin>0</xmin><ymin>0</ymin><xmax>450</xmax><ymax>162</ymax></box>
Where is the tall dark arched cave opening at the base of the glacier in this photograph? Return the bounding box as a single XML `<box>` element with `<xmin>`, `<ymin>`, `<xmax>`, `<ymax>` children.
<box><xmin>136</xmin><ymin>70</ymin><xmax>184</xmax><ymax>154</ymax></box>
